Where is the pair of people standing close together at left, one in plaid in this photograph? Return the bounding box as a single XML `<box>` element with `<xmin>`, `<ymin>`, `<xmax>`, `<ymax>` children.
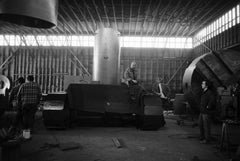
<box><xmin>9</xmin><ymin>75</ymin><xmax>42</xmax><ymax>139</ymax></box>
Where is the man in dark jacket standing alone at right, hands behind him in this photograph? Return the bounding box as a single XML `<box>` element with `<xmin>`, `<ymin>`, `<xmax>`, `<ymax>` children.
<box><xmin>199</xmin><ymin>81</ymin><xmax>216</xmax><ymax>143</ymax></box>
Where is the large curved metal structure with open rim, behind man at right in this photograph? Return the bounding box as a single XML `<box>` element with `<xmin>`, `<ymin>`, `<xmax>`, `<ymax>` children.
<box><xmin>183</xmin><ymin>49</ymin><xmax>240</xmax><ymax>111</ymax></box>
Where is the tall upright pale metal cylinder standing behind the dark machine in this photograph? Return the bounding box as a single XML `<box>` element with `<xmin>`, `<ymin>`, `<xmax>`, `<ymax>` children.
<box><xmin>93</xmin><ymin>28</ymin><xmax>120</xmax><ymax>85</ymax></box>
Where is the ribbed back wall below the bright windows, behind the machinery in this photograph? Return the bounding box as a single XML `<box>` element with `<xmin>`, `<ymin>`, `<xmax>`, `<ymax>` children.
<box><xmin>0</xmin><ymin>47</ymin><xmax>192</xmax><ymax>93</ymax></box>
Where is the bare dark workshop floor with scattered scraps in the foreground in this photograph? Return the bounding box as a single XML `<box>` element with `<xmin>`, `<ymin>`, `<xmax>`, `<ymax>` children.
<box><xmin>0</xmin><ymin>113</ymin><xmax>229</xmax><ymax>161</ymax></box>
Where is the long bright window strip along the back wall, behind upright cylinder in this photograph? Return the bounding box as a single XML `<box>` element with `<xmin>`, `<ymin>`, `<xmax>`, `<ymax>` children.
<box><xmin>0</xmin><ymin>35</ymin><xmax>192</xmax><ymax>48</ymax></box>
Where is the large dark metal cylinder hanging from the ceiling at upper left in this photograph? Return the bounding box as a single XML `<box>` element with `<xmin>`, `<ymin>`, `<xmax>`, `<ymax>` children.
<box><xmin>0</xmin><ymin>0</ymin><xmax>58</xmax><ymax>28</ymax></box>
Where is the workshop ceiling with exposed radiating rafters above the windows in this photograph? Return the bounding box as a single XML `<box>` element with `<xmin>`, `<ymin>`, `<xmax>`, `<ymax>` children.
<box><xmin>0</xmin><ymin>0</ymin><xmax>239</xmax><ymax>37</ymax></box>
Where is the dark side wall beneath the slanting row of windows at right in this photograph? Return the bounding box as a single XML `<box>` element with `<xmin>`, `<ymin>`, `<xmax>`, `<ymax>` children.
<box><xmin>194</xmin><ymin>24</ymin><xmax>240</xmax><ymax>57</ymax></box>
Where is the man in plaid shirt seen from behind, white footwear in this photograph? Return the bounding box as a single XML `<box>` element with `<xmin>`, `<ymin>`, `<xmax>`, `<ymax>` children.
<box><xmin>17</xmin><ymin>75</ymin><xmax>41</xmax><ymax>139</ymax></box>
